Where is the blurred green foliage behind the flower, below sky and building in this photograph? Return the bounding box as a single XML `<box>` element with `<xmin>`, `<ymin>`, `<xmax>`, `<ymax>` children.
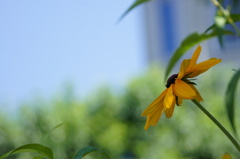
<box><xmin>0</xmin><ymin>67</ymin><xmax>240</xmax><ymax>159</ymax></box>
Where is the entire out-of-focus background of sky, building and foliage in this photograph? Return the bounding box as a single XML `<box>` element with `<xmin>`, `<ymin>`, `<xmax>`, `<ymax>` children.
<box><xmin>0</xmin><ymin>0</ymin><xmax>240</xmax><ymax>159</ymax></box>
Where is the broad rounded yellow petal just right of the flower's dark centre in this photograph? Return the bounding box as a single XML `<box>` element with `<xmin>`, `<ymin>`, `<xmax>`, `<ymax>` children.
<box><xmin>172</xmin><ymin>79</ymin><xmax>196</xmax><ymax>99</ymax></box>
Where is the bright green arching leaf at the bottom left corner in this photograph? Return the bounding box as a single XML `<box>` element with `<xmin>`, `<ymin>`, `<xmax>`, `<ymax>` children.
<box><xmin>0</xmin><ymin>144</ymin><xmax>53</xmax><ymax>159</ymax></box>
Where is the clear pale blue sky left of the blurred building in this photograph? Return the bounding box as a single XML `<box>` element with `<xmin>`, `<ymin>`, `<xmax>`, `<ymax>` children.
<box><xmin>0</xmin><ymin>0</ymin><xmax>146</xmax><ymax>112</ymax></box>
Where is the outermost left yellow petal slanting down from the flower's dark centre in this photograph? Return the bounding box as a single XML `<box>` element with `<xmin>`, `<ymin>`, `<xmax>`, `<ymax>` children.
<box><xmin>142</xmin><ymin>89</ymin><xmax>168</xmax><ymax>116</ymax></box>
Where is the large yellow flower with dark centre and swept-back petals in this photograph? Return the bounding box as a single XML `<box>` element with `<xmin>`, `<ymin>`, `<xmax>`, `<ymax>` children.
<box><xmin>142</xmin><ymin>46</ymin><xmax>222</xmax><ymax>130</ymax></box>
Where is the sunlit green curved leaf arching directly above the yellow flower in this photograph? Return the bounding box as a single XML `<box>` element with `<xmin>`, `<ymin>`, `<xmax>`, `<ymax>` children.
<box><xmin>165</xmin><ymin>30</ymin><xmax>232</xmax><ymax>79</ymax></box>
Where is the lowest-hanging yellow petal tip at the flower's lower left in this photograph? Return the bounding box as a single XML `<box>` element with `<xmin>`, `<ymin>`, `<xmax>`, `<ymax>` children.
<box><xmin>144</xmin><ymin>104</ymin><xmax>163</xmax><ymax>130</ymax></box>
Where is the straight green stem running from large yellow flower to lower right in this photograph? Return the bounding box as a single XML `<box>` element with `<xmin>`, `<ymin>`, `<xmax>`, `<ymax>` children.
<box><xmin>192</xmin><ymin>99</ymin><xmax>240</xmax><ymax>152</ymax></box>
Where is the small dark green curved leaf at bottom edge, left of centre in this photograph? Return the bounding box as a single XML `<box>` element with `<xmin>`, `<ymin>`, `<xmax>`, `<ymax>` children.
<box><xmin>74</xmin><ymin>146</ymin><xmax>110</xmax><ymax>159</ymax></box>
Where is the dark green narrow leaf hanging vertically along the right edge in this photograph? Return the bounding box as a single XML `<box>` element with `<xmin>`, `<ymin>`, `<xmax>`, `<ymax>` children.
<box><xmin>225</xmin><ymin>69</ymin><xmax>240</xmax><ymax>134</ymax></box>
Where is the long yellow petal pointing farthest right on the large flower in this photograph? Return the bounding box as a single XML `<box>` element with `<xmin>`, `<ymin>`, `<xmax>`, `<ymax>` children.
<box><xmin>188</xmin><ymin>58</ymin><xmax>222</xmax><ymax>78</ymax></box>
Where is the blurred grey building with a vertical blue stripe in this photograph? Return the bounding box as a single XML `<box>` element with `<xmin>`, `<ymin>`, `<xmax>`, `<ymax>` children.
<box><xmin>144</xmin><ymin>0</ymin><xmax>240</xmax><ymax>64</ymax></box>
